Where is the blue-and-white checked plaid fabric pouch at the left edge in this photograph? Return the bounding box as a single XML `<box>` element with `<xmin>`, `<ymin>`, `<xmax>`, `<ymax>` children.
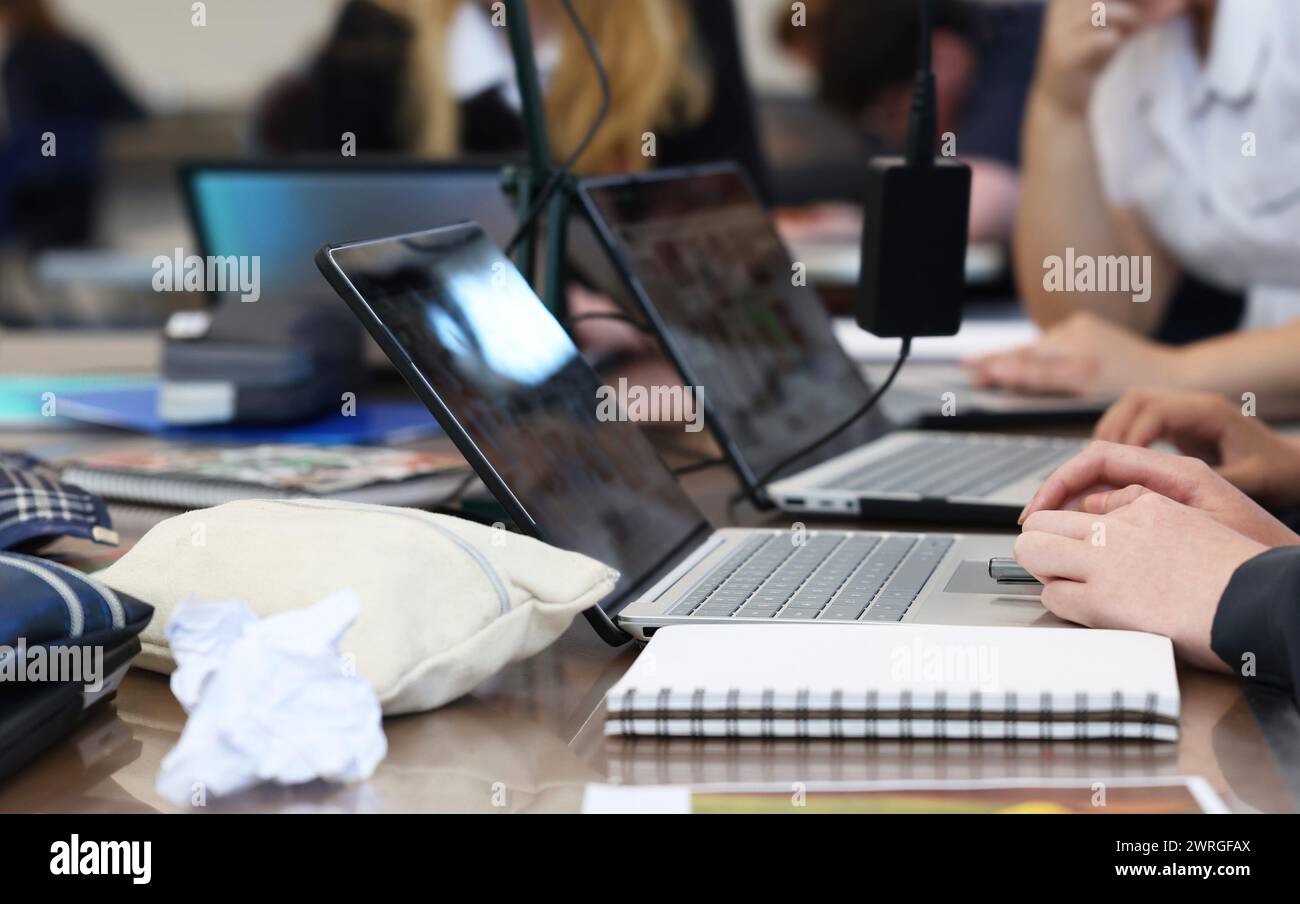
<box><xmin>0</xmin><ymin>453</ymin><xmax>117</xmax><ymax>552</ymax></box>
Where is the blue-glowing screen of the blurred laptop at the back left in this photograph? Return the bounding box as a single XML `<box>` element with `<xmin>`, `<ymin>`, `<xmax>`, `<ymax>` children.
<box><xmin>186</xmin><ymin>164</ymin><xmax>516</xmax><ymax>304</ymax></box>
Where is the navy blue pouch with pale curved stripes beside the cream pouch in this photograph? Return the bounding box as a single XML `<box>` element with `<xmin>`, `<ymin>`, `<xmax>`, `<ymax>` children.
<box><xmin>0</xmin><ymin>553</ymin><xmax>153</xmax><ymax>650</ymax></box>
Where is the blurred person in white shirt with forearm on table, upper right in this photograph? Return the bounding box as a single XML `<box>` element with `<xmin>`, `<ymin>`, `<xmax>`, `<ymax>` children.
<box><xmin>969</xmin><ymin>0</ymin><xmax>1300</xmax><ymax>416</ymax></box>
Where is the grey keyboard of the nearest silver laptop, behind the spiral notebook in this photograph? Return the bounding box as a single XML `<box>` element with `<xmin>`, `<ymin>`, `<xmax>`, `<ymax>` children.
<box><xmin>670</xmin><ymin>533</ymin><xmax>956</xmax><ymax>622</ymax></box>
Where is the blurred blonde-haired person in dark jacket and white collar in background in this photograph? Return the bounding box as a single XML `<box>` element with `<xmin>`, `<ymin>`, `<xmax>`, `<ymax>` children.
<box><xmin>257</xmin><ymin>0</ymin><xmax>767</xmax><ymax>191</ymax></box>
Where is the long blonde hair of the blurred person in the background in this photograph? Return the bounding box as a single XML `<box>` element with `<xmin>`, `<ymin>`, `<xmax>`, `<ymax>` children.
<box><xmin>376</xmin><ymin>0</ymin><xmax>712</xmax><ymax>173</ymax></box>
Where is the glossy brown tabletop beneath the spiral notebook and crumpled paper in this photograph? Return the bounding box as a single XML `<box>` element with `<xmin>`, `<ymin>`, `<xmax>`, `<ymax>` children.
<box><xmin>0</xmin><ymin>332</ymin><xmax>1300</xmax><ymax>812</ymax></box>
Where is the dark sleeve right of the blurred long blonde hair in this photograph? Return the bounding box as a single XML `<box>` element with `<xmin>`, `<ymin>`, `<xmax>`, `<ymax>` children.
<box><xmin>659</xmin><ymin>0</ymin><xmax>771</xmax><ymax>202</ymax></box>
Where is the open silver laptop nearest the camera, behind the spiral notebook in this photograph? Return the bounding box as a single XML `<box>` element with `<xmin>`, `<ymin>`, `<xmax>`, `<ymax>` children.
<box><xmin>317</xmin><ymin>225</ymin><xmax>1060</xmax><ymax>643</ymax></box>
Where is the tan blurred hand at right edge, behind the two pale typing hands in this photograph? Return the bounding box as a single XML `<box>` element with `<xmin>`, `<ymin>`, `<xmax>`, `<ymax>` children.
<box><xmin>1095</xmin><ymin>389</ymin><xmax>1300</xmax><ymax>507</ymax></box>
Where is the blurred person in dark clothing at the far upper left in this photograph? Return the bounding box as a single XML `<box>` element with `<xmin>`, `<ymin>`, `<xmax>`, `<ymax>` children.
<box><xmin>0</xmin><ymin>0</ymin><xmax>143</xmax><ymax>251</ymax></box>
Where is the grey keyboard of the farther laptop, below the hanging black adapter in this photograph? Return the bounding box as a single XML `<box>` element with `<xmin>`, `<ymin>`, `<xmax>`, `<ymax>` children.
<box><xmin>828</xmin><ymin>436</ymin><xmax>1079</xmax><ymax>498</ymax></box>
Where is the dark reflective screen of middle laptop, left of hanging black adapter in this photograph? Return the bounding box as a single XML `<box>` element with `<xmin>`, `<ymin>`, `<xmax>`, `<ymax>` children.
<box><xmin>582</xmin><ymin>166</ymin><xmax>881</xmax><ymax>481</ymax></box>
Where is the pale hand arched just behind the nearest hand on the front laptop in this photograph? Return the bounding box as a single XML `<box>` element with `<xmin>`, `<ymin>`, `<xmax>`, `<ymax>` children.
<box><xmin>1021</xmin><ymin>442</ymin><xmax>1300</xmax><ymax>548</ymax></box>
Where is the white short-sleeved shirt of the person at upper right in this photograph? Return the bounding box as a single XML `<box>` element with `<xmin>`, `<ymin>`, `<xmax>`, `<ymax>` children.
<box><xmin>1089</xmin><ymin>0</ymin><xmax>1300</xmax><ymax>328</ymax></box>
